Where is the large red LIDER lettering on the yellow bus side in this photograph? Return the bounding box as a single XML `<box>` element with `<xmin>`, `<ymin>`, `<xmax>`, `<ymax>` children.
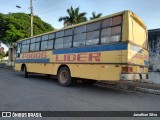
<box><xmin>56</xmin><ymin>53</ymin><xmax>101</xmax><ymax>62</ymax></box>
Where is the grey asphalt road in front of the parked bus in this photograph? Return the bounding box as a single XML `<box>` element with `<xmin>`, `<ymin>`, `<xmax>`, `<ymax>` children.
<box><xmin>0</xmin><ymin>68</ymin><xmax>160</xmax><ymax>120</ymax></box>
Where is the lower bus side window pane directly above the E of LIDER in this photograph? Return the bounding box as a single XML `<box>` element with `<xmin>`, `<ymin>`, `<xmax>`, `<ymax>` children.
<box><xmin>73</xmin><ymin>33</ymin><xmax>86</xmax><ymax>47</ymax></box>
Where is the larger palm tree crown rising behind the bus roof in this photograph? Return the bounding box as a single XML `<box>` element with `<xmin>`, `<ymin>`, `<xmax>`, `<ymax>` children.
<box><xmin>59</xmin><ymin>6</ymin><xmax>87</xmax><ymax>25</ymax></box>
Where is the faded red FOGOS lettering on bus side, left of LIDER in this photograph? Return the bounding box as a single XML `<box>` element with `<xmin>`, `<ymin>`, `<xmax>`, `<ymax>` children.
<box><xmin>22</xmin><ymin>52</ymin><xmax>47</xmax><ymax>59</ymax></box>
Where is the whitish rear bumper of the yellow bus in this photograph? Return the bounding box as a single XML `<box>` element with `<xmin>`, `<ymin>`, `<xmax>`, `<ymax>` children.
<box><xmin>121</xmin><ymin>73</ymin><xmax>148</xmax><ymax>80</ymax></box>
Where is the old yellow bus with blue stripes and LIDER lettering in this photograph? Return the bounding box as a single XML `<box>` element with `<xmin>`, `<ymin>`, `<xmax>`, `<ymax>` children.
<box><xmin>15</xmin><ymin>11</ymin><xmax>149</xmax><ymax>86</ymax></box>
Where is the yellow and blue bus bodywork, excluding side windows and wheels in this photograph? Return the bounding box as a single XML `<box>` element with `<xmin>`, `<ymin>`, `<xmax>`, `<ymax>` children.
<box><xmin>15</xmin><ymin>11</ymin><xmax>148</xmax><ymax>81</ymax></box>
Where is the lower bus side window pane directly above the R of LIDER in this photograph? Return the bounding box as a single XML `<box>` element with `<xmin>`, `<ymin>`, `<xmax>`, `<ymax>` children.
<box><xmin>86</xmin><ymin>30</ymin><xmax>99</xmax><ymax>45</ymax></box>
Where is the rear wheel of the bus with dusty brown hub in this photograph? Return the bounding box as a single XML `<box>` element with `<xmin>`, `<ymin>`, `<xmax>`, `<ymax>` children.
<box><xmin>58</xmin><ymin>67</ymin><xmax>74</xmax><ymax>87</ymax></box>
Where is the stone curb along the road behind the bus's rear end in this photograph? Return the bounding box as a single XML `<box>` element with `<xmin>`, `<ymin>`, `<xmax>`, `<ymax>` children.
<box><xmin>95</xmin><ymin>82</ymin><xmax>160</xmax><ymax>95</ymax></box>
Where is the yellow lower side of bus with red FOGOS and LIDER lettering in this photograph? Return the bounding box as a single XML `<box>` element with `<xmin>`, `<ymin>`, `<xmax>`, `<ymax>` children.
<box><xmin>15</xmin><ymin>46</ymin><xmax>121</xmax><ymax>80</ymax></box>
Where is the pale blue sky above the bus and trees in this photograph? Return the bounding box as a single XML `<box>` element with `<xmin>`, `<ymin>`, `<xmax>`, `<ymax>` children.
<box><xmin>0</xmin><ymin>0</ymin><xmax>160</xmax><ymax>50</ymax></box>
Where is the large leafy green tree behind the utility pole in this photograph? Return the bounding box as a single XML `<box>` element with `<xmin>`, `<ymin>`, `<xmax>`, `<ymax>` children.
<box><xmin>0</xmin><ymin>13</ymin><xmax>54</xmax><ymax>46</ymax></box>
